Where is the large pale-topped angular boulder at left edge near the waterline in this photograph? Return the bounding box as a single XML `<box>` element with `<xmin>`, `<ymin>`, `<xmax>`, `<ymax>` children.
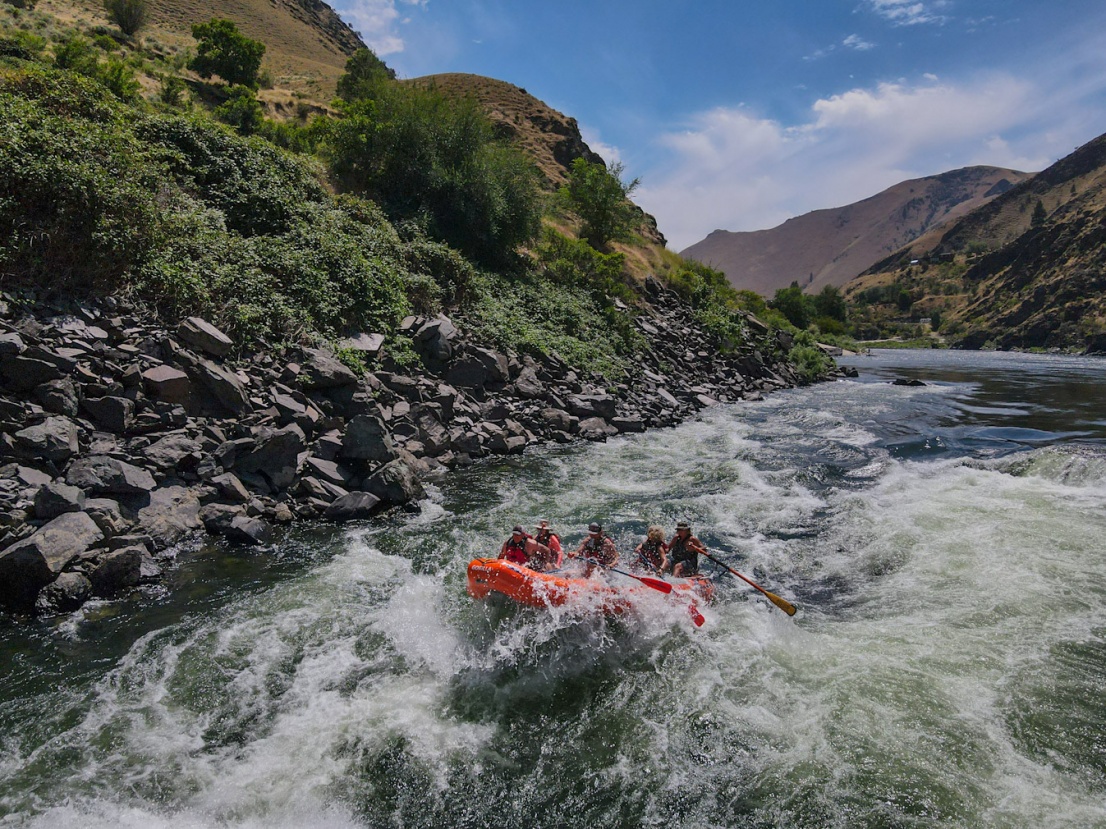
<box><xmin>0</xmin><ymin>513</ymin><xmax>104</xmax><ymax>607</ymax></box>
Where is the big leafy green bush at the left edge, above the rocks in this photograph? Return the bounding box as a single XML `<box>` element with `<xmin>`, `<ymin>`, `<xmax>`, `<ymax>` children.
<box><xmin>0</xmin><ymin>72</ymin><xmax>166</xmax><ymax>293</ymax></box>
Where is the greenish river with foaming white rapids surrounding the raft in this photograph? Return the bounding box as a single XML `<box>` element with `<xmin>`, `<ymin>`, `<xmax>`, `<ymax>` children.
<box><xmin>0</xmin><ymin>351</ymin><xmax>1106</xmax><ymax>829</ymax></box>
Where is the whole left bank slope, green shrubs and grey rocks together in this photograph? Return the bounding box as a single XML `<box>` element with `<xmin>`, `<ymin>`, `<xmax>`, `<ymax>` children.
<box><xmin>0</xmin><ymin>6</ymin><xmax>836</xmax><ymax>615</ymax></box>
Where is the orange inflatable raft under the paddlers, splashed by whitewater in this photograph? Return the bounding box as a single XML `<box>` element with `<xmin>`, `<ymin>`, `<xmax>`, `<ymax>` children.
<box><xmin>469</xmin><ymin>558</ymin><xmax>714</xmax><ymax>623</ymax></box>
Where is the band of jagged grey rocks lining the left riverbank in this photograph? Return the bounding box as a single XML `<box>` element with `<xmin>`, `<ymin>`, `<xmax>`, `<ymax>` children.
<box><xmin>0</xmin><ymin>283</ymin><xmax>831</xmax><ymax>613</ymax></box>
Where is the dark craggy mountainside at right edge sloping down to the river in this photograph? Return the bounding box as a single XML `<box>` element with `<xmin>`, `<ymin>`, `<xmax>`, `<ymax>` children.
<box><xmin>845</xmin><ymin>135</ymin><xmax>1106</xmax><ymax>351</ymax></box>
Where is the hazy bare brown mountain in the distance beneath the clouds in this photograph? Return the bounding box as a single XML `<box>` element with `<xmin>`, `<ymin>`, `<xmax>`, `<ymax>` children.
<box><xmin>682</xmin><ymin>167</ymin><xmax>1031</xmax><ymax>296</ymax></box>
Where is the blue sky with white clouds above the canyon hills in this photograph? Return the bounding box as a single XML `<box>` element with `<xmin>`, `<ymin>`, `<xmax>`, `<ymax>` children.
<box><xmin>335</xmin><ymin>0</ymin><xmax>1106</xmax><ymax>250</ymax></box>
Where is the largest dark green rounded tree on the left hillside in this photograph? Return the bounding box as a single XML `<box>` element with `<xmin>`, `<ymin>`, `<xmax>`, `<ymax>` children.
<box><xmin>323</xmin><ymin>84</ymin><xmax>541</xmax><ymax>265</ymax></box>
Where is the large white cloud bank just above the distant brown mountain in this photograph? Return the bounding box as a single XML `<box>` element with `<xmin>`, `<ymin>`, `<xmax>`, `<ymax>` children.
<box><xmin>635</xmin><ymin>75</ymin><xmax>1087</xmax><ymax>250</ymax></box>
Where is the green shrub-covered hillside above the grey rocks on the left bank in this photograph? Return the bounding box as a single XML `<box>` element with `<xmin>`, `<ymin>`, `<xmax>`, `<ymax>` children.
<box><xmin>0</xmin><ymin>6</ymin><xmax>817</xmax><ymax>380</ymax></box>
